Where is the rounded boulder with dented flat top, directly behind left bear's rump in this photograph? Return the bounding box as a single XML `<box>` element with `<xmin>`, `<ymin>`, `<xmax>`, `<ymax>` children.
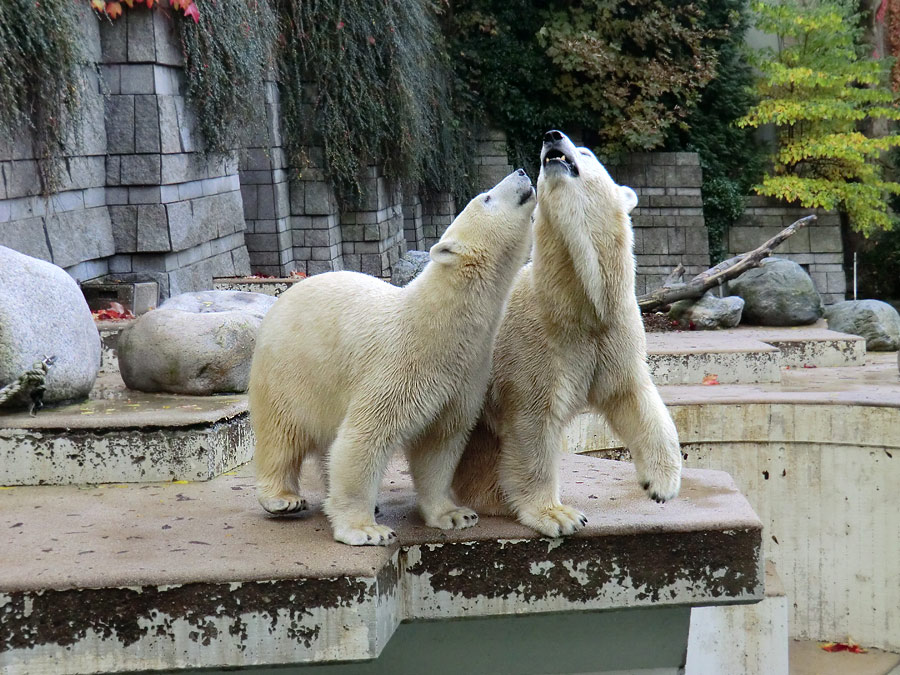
<box><xmin>117</xmin><ymin>291</ymin><xmax>276</xmax><ymax>395</ymax></box>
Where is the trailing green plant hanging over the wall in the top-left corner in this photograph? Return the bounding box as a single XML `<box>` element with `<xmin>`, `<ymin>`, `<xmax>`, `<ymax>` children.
<box><xmin>0</xmin><ymin>0</ymin><xmax>85</xmax><ymax>192</ymax></box>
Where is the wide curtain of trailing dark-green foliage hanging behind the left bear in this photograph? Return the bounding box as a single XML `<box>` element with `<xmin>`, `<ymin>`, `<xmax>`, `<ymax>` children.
<box><xmin>277</xmin><ymin>0</ymin><xmax>473</xmax><ymax>206</ymax></box>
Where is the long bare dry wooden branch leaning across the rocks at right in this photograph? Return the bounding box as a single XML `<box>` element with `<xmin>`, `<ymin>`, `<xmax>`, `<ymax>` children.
<box><xmin>638</xmin><ymin>215</ymin><xmax>816</xmax><ymax>312</ymax></box>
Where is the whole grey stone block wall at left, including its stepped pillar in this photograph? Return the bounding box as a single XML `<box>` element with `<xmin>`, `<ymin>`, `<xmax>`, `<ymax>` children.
<box><xmin>0</xmin><ymin>3</ymin><xmax>250</xmax><ymax>298</ymax></box>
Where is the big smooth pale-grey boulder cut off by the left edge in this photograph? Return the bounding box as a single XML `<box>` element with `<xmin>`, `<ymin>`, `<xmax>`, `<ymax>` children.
<box><xmin>0</xmin><ymin>246</ymin><xmax>100</xmax><ymax>402</ymax></box>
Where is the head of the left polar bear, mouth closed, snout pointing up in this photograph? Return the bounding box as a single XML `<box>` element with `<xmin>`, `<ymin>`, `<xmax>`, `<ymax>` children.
<box><xmin>430</xmin><ymin>169</ymin><xmax>535</xmax><ymax>279</ymax></box>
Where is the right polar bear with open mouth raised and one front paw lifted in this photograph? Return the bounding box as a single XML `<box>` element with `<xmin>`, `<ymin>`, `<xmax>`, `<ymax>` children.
<box><xmin>453</xmin><ymin>131</ymin><xmax>681</xmax><ymax>537</ymax></box>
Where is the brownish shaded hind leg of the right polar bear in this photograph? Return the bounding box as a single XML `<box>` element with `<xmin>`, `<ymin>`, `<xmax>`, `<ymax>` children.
<box><xmin>453</xmin><ymin>417</ymin><xmax>509</xmax><ymax>515</ymax></box>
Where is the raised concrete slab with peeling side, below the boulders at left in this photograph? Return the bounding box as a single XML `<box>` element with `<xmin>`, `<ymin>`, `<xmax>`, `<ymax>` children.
<box><xmin>0</xmin><ymin>390</ymin><xmax>253</xmax><ymax>485</ymax></box>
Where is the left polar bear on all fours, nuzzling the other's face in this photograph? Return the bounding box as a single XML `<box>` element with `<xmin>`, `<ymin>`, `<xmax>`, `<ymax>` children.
<box><xmin>249</xmin><ymin>169</ymin><xmax>535</xmax><ymax>545</ymax></box>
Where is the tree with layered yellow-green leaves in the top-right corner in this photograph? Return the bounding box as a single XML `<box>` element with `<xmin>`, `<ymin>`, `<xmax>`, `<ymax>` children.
<box><xmin>738</xmin><ymin>0</ymin><xmax>900</xmax><ymax>235</ymax></box>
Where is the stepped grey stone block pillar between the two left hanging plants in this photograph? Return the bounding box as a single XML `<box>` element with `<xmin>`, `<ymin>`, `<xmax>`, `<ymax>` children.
<box><xmin>100</xmin><ymin>7</ymin><xmax>250</xmax><ymax>298</ymax></box>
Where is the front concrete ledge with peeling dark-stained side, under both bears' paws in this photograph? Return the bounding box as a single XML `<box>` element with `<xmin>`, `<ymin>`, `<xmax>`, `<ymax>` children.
<box><xmin>0</xmin><ymin>456</ymin><xmax>763</xmax><ymax>675</ymax></box>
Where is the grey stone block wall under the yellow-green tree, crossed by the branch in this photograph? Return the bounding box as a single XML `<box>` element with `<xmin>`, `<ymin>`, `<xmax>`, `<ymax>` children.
<box><xmin>728</xmin><ymin>196</ymin><xmax>847</xmax><ymax>305</ymax></box>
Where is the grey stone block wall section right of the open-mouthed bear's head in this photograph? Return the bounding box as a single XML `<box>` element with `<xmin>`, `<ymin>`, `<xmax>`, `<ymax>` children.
<box><xmin>608</xmin><ymin>152</ymin><xmax>709</xmax><ymax>294</ymax></box>
